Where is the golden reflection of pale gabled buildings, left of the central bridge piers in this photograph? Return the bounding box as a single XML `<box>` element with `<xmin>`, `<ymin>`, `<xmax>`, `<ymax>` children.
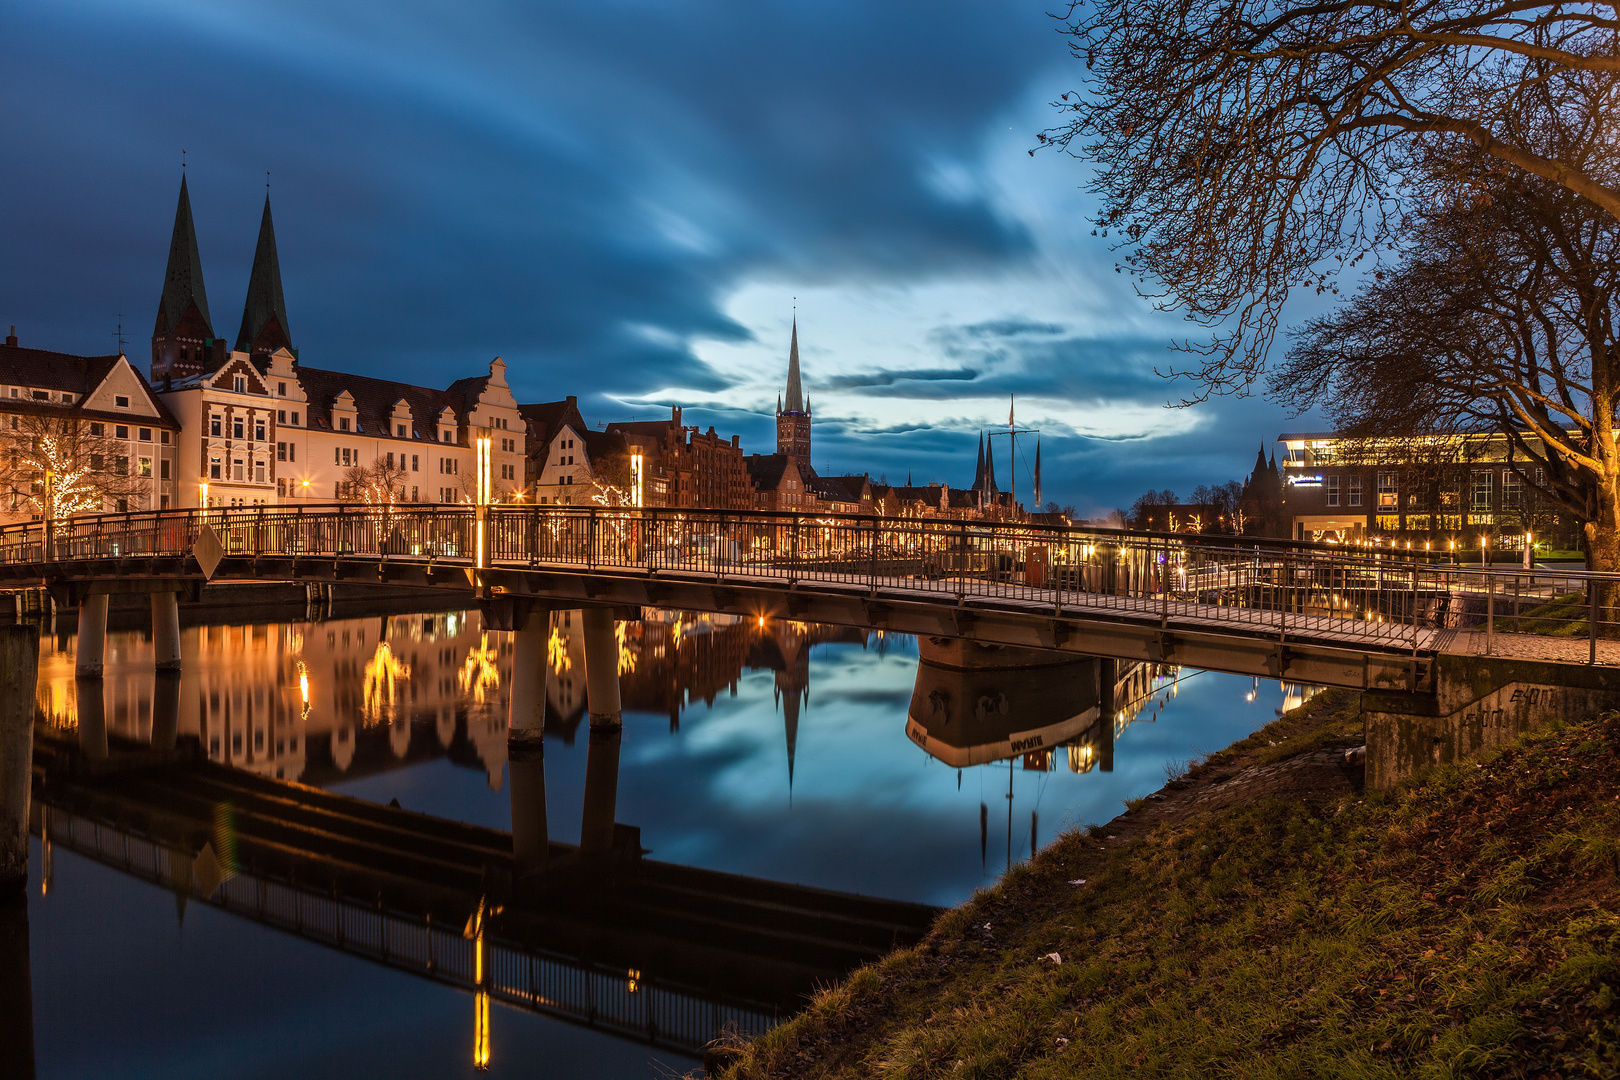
<box><xmin>39</xmin><ymin>612</ymin><xmax>510</xmax><ymax>785</ymax></box>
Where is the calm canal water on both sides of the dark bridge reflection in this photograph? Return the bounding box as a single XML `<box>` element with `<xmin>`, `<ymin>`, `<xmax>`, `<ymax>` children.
<box><xmin>28</xmin><ymin>610</ymin><xmax>1301</xmax><ymax>1078</ymax></box>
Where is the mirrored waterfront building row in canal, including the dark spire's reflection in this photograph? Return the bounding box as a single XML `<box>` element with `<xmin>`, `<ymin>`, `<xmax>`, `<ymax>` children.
<box><xmin>28</xmin><ymin>609</ymin><xmax>887</xmax><ymax>789</ymax></box>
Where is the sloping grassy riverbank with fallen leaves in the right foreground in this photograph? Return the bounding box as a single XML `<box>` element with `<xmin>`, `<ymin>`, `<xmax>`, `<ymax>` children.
<box><xmin>713</xmin><ymin>693</ymin><xmax>1620</xmax><ymax>1080</ymax></box>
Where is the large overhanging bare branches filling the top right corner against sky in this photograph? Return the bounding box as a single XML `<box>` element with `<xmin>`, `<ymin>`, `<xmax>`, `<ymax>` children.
<box><xmin>1040</xmin><ymin>0</ymin><xmax>1620</xmax><ymax>402</ymax></box>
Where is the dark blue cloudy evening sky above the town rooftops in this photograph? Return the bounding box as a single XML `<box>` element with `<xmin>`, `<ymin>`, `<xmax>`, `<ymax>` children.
<box><xmin>0</xmin><ymin>0</ymin><xmax>1309</xmax><ymax>512</ymax></box>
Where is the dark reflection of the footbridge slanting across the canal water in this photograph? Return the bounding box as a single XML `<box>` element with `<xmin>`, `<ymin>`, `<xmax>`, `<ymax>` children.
<box><xmin>25</xmin><ymin>729</ymin><xmax>936</xmax><ymax>1054</ymax></box>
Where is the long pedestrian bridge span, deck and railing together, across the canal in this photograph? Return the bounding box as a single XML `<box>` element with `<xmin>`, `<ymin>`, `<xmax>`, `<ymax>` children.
<box><xmin>0</xmin><ymin>504</ymin><xmax>1620</xmax><ymax>691</ymax></box>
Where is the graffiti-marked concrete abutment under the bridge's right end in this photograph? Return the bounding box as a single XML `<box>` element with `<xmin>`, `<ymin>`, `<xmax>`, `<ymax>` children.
<box><xmin>1361</xmin><ymin>656</ymin><xmax>1620</xmax><ymax>790</ymax></box>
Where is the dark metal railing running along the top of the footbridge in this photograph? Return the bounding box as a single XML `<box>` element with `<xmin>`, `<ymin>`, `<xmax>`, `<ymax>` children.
<box><xmin>9</xmin><ymin>504</ymin><xmax>1620</xmax><ymax>661</ymax></box>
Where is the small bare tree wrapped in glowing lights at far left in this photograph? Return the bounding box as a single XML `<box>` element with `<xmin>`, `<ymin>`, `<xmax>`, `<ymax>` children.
<box><xmin>0</xmin><ymin>411</ymin><xmax>151</xmax><ymax>520</ymax></box>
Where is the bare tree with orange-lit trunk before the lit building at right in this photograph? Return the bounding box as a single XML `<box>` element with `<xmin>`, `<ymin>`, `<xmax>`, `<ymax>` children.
<box><xmin>1273</xmin><ymin>113</ymin><xmax>1620</xmax><ymax>570</ymax></box>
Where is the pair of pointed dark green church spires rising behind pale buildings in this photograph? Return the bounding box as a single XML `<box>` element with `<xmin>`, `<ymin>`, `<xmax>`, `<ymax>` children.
<box><xmin>152</xmin><ymin>176</ymin><xmax>296</xmax><ymax>385</ymax></box>
